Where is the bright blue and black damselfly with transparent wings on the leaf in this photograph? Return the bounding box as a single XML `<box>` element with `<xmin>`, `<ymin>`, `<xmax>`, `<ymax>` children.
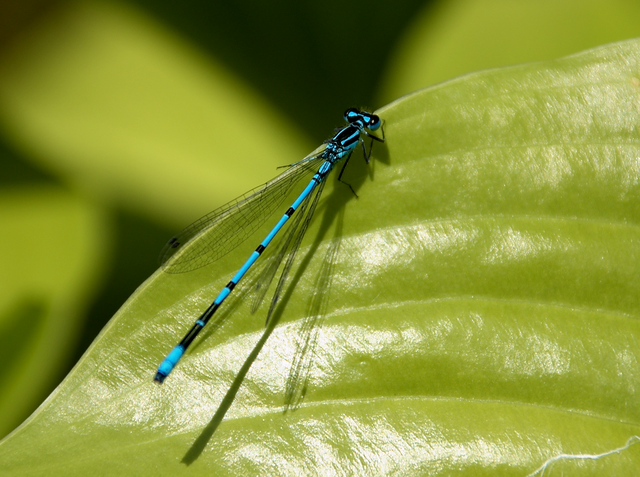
<box><xmin>154</xmin><ymin>108</ymin><xmax>384</xmax><ymax>383</ymax></box>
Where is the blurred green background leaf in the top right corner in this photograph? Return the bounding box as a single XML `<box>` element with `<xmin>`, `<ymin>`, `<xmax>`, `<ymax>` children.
<box><xmin>379</xmin><ymin>0</ymin><xmax>640</xmax><ymax>103</ymax></box>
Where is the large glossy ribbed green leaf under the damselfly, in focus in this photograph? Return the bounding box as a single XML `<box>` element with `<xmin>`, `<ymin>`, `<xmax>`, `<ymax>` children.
<box><xmin>0</xmin><ymin>41</ymin><xmax>640</xmax><ymax>476</ymax></box>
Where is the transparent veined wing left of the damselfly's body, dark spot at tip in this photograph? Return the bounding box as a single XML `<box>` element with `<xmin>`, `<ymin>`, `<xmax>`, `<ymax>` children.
<box><xmin>160</xmin><ymin>148</ymin><xmax>324</xmax><ymax>273</ymax></box>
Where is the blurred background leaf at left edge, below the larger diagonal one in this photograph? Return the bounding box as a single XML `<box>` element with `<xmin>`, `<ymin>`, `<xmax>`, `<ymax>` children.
<box><xmin>0</xmin><ymin>186</ymin><xmax>111</xmax><ymax>440</ymax></box>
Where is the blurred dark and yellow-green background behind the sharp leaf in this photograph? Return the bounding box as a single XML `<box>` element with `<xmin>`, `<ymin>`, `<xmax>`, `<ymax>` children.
<box><xmin>0</xmin><ymin>0</ymin><xmax>640</xmax><ymax>436</ymax></box>
